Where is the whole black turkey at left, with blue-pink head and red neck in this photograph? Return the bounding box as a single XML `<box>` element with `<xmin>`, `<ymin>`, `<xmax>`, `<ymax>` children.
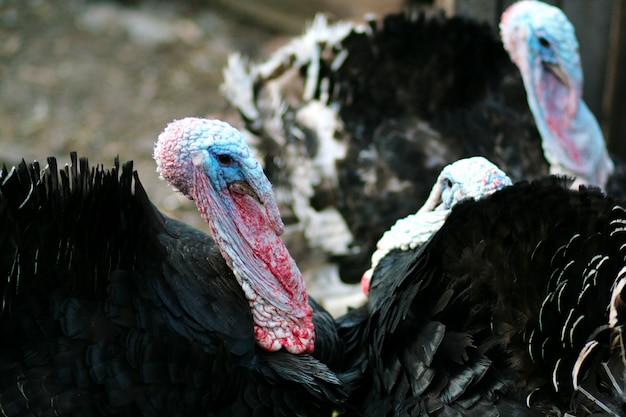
<box><xmin>0</xmin><ymin>118</ymin><xmax>346</xmax><ymax>416</ymax></box>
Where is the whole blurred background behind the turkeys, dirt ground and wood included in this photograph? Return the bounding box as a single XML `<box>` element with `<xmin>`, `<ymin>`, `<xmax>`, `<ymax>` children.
<box><xmin>0</xmin><ymin>0</ymin><xmax>626</xmax><ymax>228</ymax></box>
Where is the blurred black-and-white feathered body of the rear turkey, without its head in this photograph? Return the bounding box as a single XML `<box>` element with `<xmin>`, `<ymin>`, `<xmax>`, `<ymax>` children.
<box><xmin>222</xmin><ymin>6</ymin><xmax>549</xmax><ymax>283</ymax></box>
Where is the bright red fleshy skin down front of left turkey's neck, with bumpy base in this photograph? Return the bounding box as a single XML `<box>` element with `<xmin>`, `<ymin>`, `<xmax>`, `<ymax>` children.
<box><xmin>230</xmin><ymin>187</ymin><xmax>315</xmax><ymax>353</ymax></box>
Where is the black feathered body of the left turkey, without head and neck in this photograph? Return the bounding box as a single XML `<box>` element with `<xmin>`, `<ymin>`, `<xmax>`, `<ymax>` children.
<box><xmin>0</xmin><ymin>154</ymin><xmax>344</xmax><ymax>416</ymax></box>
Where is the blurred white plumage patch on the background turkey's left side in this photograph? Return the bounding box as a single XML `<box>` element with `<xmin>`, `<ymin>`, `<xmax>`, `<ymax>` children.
<box><xmin>221</xmin><ymin>14</ymin><xmax>358</xmax><ymax>255</ymax></box>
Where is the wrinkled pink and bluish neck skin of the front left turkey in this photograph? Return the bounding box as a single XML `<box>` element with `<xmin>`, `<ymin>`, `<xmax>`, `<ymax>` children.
<box><xmin>194</xmin><ymin>151</ymin><xmax>315</xmax><ymax>353</ymax></box>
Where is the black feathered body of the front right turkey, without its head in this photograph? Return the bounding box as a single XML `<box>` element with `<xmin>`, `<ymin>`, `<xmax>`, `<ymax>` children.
<box><xmin>340</xmin><ymin>176</ymin><xmax>626</xmax><ymax>416</ymax></box>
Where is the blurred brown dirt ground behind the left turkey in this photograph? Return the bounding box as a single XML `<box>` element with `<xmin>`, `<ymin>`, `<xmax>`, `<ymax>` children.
<box><xmin>0</xmin><ymin>0</ymin><xmax>277</xmax><ymax>227</ymax></box>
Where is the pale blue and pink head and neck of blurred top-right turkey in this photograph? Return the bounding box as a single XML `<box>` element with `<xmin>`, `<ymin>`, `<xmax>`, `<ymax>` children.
<box><xmin>500</xmin><ymin>0</ymin><xmax>614</xmax><ymax>187</ymax></box>
